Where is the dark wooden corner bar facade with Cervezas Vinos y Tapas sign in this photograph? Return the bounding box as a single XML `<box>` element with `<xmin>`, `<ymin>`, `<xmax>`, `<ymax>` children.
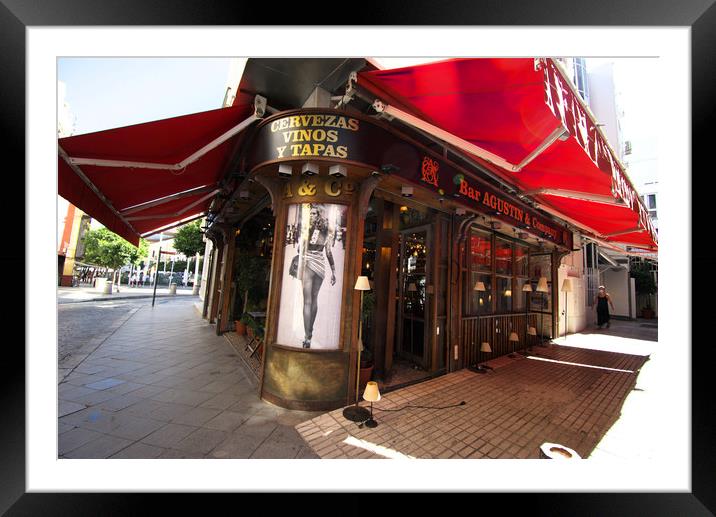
<box><xmin>203</xmin><ymin>108</ymin><xmax>574</xmax><ymax>410</ymax></box>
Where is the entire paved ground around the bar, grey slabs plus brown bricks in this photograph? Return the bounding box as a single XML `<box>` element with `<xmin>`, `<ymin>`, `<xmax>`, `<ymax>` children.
<box><xmin>58</xmin><ymin>297</ymin><xmax>655</xmax><ymax>459</ymax></box>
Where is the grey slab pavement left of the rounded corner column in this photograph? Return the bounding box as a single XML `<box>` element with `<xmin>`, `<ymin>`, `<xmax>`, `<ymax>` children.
<box><xmin>58</xmin><ymin>297</ymin><xmax>317</xmax><ymax>459</ymax></box>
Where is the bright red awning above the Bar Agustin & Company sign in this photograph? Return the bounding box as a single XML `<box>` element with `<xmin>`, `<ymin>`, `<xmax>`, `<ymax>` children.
<box><xmin>358</xmin><ymin>58</ymin><xmax>657</xmax><ymax>250</ymax></box>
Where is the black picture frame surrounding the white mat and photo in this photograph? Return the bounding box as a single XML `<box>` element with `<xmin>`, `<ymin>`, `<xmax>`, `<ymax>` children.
<box><xmin>0</xmin><ymin>0</ymin><xmax>716</xmax><ymax>516</ymax></box>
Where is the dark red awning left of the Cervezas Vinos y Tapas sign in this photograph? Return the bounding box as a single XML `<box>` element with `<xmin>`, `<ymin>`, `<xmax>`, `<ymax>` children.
<box><xmin>58</xmin><ymin>96</ymin><xmax>258</xmax><ymax>245</ymax></box>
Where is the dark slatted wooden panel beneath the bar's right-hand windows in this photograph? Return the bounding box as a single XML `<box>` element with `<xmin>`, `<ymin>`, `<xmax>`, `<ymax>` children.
<box><xmin>461</xmin><ymin>313</ymin><xmax>539</xmax><ymax>366</ymax></box>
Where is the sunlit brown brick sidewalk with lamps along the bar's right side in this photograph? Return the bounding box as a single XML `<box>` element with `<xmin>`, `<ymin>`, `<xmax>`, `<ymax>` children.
<box><xmin>296</xmin><ymin>322</ymin><xmax>658</xmax><ymax>459</ymax></box>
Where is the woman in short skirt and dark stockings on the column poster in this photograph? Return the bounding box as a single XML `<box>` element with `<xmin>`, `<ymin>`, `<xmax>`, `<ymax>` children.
<box><xmin>291</xmin><ymin>204</ymin><xmax>336</xmax><ymax>348</ymax></box>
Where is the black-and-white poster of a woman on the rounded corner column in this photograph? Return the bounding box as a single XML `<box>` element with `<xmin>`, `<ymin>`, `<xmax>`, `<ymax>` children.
<box><xmin>277</xmin><ymin>203</ymin><xmax>348</xmax><ymax>350</ymax></box>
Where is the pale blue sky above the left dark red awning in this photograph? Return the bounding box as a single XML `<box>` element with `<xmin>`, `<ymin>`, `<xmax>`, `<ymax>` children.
<box><xmin>57</xmin><ymin>57</ymin><xmax>230</xmax><ymax>135</ymax></box>
